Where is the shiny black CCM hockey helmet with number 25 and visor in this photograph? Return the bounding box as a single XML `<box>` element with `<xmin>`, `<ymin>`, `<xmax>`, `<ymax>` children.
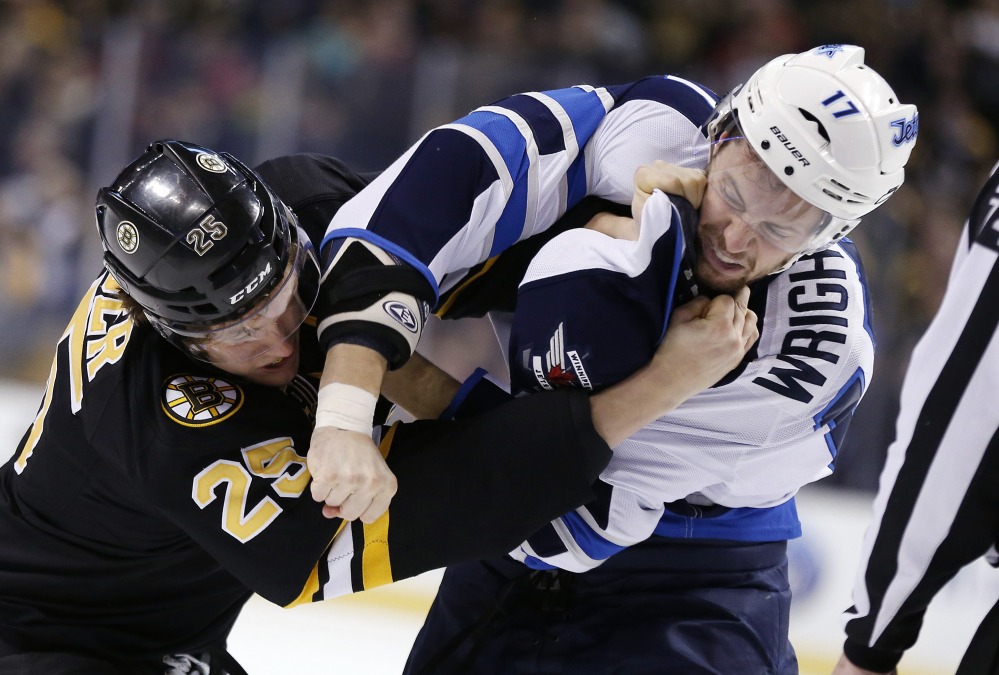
<box><xmin>96</xmin><ymin>140</ymin><xmax>319</xmax><ymax>362</ymax></box>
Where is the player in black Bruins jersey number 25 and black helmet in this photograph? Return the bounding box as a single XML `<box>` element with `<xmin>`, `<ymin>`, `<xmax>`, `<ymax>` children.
<box><xmin>0</xmin><ymin>141</ymin><xmax>757</xmax><ymax>675</ymax></box>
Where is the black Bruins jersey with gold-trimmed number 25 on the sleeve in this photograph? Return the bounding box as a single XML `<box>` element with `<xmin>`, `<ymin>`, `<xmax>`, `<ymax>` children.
<box><xmin>0</xmin><ymin>155</ymin><xmax>609</xmax><ymax>672</ymax></box>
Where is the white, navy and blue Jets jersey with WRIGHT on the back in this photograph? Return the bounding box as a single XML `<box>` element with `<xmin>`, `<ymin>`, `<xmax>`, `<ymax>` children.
<box><xmin>323</xmin><ymin>71</ymin><xmax>873</xmax><ymax>569</ymax></box>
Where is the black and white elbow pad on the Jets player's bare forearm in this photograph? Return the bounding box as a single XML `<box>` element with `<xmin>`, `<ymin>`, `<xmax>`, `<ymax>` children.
<box><xmin>316</xmin><ymin>238</ymin><xmax>433</xmax><ymax>369</ymax></box>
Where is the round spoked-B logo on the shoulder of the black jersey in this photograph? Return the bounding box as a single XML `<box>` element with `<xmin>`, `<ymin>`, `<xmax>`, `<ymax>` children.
<box><xmin>162</xmin><ymin>375</ymin><xmax>244</xmax><ymax>427</ymax></box>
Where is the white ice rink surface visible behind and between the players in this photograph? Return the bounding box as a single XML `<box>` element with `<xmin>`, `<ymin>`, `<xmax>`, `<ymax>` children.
<box><xmin>0</xmin><ymin>374</ymin><xmax>999</xmax><ymax>675</ymax></box>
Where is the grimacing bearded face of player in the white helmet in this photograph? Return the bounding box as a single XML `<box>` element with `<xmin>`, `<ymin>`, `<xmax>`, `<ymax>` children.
<box><xmin>694</xmin><ymin>138</ymin><xmax>823</xmax><ymax>293</ymax></box>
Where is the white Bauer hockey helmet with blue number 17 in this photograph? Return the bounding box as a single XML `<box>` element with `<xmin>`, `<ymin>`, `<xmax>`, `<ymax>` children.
<box><xmin>708</xmin><ymin>45</ymin><xmax>919</xmax><ymax>253</ymax></box>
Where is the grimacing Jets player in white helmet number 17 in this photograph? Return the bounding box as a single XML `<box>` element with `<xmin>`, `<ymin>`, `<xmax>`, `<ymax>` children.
<box><xmin>313</xmin><ymin>45</ymin><xmax>918</xmax><ymax>673</ymax></box>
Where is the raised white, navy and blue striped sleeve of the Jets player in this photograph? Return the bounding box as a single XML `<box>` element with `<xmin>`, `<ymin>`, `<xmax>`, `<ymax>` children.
<box><xmin>324</xmin><ymin>77</ymin><xmax>716</xmax><ymax>302</ymax></box>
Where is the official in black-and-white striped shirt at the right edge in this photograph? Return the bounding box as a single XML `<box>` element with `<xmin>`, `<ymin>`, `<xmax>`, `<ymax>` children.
<box><xmin>833</xmin><ymin>160</ymin><xmax>999</xmax><ymax>675</ymax></box>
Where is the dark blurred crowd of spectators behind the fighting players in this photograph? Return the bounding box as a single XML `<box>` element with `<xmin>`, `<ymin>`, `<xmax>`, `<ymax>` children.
<box><xmin>0</xmin><ymin>0</ymin><xmax>999</xmax><ymax>490</ymax></box>
